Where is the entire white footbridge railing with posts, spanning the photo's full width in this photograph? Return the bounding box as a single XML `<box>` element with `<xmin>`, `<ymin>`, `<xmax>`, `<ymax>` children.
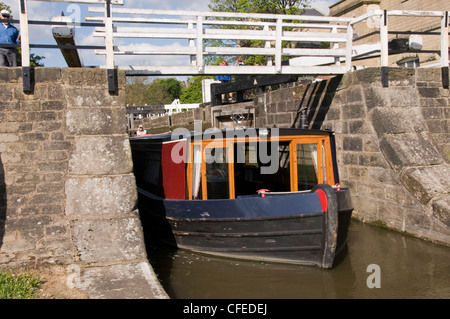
<box><xmin>13</xmin><ymin>0</ymin><xmax>449</xmax><ymax>79</ymax></box>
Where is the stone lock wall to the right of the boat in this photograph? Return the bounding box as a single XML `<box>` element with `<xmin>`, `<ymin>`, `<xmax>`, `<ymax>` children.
<box><xmin>255</xmin><ymin>68</ymin><xmax>450</xmax><ymax>245</ymax></box>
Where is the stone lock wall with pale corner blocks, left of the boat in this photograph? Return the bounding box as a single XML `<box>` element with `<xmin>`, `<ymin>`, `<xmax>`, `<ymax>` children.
<box><xmin>0</xmin><ymin>68</ymin><xmax>166</xmax><ymax>298</ymax></box>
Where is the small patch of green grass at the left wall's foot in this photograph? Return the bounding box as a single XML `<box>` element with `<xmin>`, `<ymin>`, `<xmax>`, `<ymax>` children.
<box><xmin>0</xmin><ymin>271</ymin><xmax>41</xmax><ymax>299</ymax></box>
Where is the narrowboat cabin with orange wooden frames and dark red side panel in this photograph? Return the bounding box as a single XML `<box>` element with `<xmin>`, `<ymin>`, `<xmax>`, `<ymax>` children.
<box><xmin>130</xmin><ymin>128</ymin><xmax>339</xmax><ymax>200</ymax></box>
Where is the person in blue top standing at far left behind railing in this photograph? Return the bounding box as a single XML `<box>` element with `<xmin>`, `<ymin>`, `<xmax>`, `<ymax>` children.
<box><xmin>0</xmin><ymin>10</ymin><xmax>19</xmax><ymax>66</ymax></box>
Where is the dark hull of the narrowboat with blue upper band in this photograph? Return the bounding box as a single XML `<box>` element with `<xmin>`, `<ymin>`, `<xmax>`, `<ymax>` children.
<box><xmin>139</xmin><ymin>185</ymin><xmax>353</xmax><ymax>268</ymax></box>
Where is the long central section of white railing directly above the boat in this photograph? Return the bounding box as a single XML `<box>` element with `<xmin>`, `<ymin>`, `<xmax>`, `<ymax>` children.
<box><xmin>86</xmin><ymin>7</ymin><xmax>353</xmax><ymax>75</ymax></box>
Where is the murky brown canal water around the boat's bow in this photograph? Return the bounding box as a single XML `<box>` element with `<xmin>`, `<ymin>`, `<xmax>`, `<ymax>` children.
<box><xmin>148</xmin><ymin>220</ymin><xmax>450</xmax><ymax>299</ymax></box>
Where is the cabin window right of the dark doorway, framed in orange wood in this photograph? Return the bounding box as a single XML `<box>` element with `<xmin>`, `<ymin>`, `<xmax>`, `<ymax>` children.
<box><xmin>297</xmin><ymin>144</ymin><xmax>318</xmax><ymax>190</ymax></box>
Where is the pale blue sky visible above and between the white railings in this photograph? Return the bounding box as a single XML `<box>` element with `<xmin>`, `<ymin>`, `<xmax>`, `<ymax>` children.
<box><xmin>5</xmin><ymin>0</ymin><xmax>338</xmax><ymax>67</ymax></box>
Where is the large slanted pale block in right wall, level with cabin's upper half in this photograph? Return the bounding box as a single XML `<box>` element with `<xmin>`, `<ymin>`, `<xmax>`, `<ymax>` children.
<box><xmin>380</xmin><ymin>133</ymin><xmax>442</xmax><ymax>171</ymax></box>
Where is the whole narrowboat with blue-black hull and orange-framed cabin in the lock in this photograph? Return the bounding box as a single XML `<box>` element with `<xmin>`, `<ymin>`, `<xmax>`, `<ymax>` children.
<box><xmin>130</xmin><ymin>128</ymin><xmax>353</xmax><ymax>268</ymax></box>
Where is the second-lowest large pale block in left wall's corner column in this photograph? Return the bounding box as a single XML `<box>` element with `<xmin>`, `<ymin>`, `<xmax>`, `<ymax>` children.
<box><xmin>71</xmin><ymin>216</ymin><xmax>146</xmax><ymax>263</ymax></box>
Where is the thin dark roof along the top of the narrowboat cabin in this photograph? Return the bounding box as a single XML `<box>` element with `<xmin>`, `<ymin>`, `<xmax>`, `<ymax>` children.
<box><xmin>130</xmin><ymin>128</ymin><xmax>333</xmax><ymax>143</ymax></box>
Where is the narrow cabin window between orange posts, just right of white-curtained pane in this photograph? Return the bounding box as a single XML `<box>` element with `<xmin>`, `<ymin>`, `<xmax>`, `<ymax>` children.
<box><xmin>205</xmin><ymin>147</ymin><xmax>230</xmax><ymax>199</ymax></box>
